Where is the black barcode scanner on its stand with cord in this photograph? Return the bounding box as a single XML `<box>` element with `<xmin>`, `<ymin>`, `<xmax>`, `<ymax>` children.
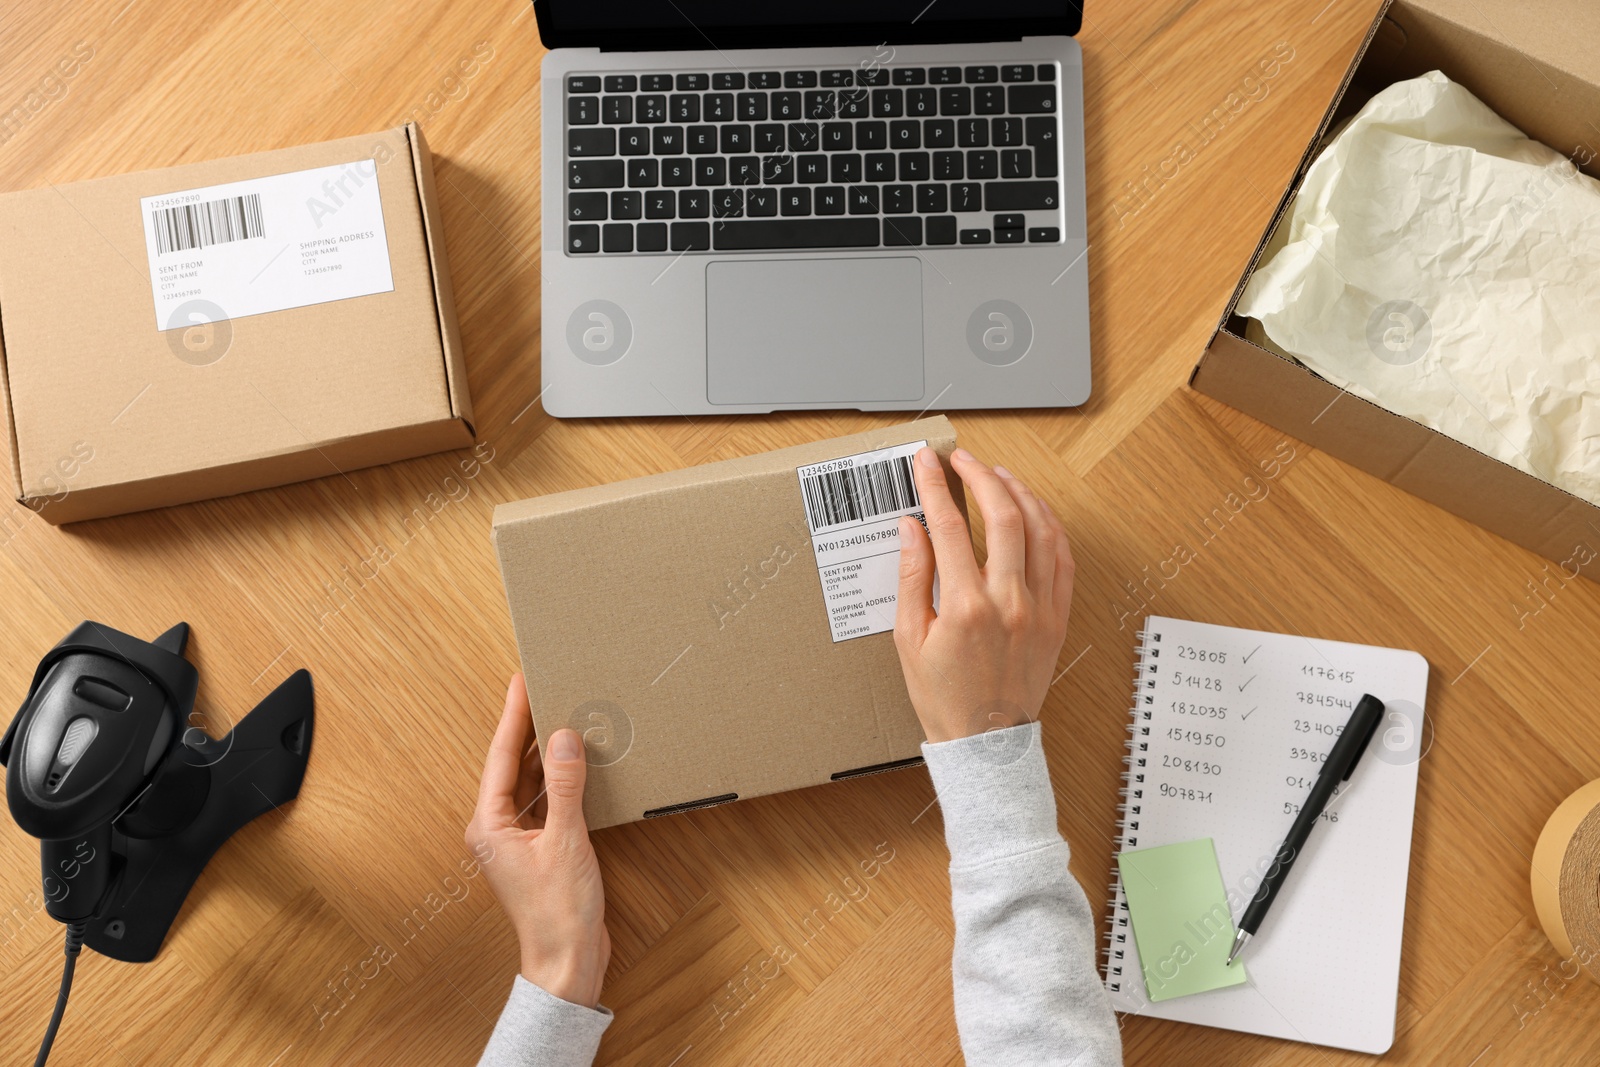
<box><xmin>0</xmin><ymin>622</ymin><xmax>314</xmax><ymax>1065</ymax></box>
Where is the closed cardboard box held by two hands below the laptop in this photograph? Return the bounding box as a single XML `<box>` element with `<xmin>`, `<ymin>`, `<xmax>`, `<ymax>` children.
<box><xmin>494</xmin><ymin>416</ymin><xmax>962</xmax><ymax>829</ymax></box>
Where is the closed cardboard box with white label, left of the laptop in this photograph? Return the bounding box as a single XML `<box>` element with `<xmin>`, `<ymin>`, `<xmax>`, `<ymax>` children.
<box><xmin>0</xmin><ymin>125</ymin><xmax>474</xmax><ymax>523</ymax></box>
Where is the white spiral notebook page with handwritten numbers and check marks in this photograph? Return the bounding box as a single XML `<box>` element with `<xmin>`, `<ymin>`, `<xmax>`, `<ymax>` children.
<box><xmin>1104</xmin><ymin>616</ymin><xmax>1432</xmax><ymax>1053</ymax></box>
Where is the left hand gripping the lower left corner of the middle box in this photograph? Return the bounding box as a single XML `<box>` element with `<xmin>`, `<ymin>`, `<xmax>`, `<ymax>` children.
<box><xmin>467</xmin><ymin>675</ymin><xmax>611</xmax><ymax>1008</ymax></box>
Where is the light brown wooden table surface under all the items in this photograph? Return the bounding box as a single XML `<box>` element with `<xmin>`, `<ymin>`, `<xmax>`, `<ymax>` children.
<box><xmin>0</xmin><ymin>0</ymin><xmax>1600</xmax><ymax>1067</ymax></box>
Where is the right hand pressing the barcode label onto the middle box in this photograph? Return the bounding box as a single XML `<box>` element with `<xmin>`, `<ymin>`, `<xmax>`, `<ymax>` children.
<box><xmin>894</xmin><ymin>448</ymin><xmax>1072</xmax><ymax>741</ymax></box>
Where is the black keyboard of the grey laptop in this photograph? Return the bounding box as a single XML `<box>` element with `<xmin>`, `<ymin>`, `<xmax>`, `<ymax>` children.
<box><xmin>563</xmin><ymin>64</ymin><xmax>1062</xmax><ymax>254</ymax></box>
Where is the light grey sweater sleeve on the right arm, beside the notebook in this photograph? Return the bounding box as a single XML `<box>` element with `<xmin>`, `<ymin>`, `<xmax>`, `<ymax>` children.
<box><xmin>922</xmin><ymin>723</ymin><xmax>1122</xmax><ymax>1067</ymax></box>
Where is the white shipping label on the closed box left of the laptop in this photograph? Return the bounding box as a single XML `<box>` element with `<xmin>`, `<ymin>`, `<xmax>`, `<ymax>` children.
<box><xmin>139</xmin><ymin>158</ymin><xmax>395</xmax><ymax>329</ymax></box>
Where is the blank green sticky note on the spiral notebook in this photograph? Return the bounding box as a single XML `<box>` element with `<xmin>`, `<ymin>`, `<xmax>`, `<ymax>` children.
<box><xmin>1117</xmin><ymin>837</ymin><xmax>1245</xmax><ymax>1001</ymax></box>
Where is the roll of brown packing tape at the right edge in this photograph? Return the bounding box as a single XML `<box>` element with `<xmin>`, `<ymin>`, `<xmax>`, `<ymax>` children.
<box><xmin>1533</xmin><ymin>779</ymin><xmax>1600</xmax><ymax>982</ymax></box>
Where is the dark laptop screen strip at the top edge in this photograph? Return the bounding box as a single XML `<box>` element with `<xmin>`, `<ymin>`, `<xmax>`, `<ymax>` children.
<box><xmin>533</xmin><ymin>0</ymin><xmax>1083</xmax><ymax>51</ymax></box>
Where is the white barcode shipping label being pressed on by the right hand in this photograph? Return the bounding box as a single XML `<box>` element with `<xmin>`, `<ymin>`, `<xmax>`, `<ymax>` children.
<box><xmin>797</xmin><ymin>442</ymin><xmax>928</xmax><ymax>641</ymax></box>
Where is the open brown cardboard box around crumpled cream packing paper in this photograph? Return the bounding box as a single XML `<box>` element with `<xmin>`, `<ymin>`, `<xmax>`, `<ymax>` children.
<box><xmin>1189</xmin><ymin>0</ymin><xmax>1600</xmax><ymax>577</ymax></box>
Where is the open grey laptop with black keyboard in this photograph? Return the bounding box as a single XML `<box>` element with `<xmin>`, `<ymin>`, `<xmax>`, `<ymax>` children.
<box><xmin>533</xmin><ymin>0</ymin><xmax>1090</xmax><ymax>418</ymax></box>
